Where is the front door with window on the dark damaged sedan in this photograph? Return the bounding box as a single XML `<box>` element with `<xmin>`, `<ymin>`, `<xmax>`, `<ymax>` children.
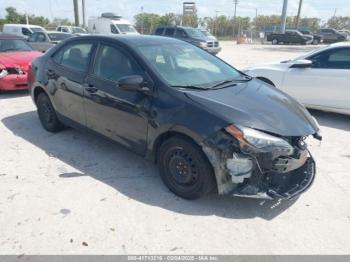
<box><xmin>84</xmin><ymin>44</ymin><xmax>151</xmax><ymax>154</ymax></box>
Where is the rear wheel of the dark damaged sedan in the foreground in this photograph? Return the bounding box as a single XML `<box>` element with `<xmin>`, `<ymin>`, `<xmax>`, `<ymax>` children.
<box><xmin>36</xmin><ymin>92</ymin><xmax>64</xmax><ymax>133</ymax></box>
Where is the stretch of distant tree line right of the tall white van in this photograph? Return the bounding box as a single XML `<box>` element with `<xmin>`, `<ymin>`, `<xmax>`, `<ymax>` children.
<box><xmin>134</xmin><ymin>13</ymin><xmax>350</xmax><ymax>37</ymax></box>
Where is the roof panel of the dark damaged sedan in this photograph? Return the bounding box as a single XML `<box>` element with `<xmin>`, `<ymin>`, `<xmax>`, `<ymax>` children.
<box><xmin>74</xmin><ymin>35</ymin><xmax>184</xmax><ymax>46</ymax></box>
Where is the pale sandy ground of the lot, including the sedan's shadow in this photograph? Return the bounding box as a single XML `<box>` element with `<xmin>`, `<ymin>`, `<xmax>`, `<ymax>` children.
<box><xmin>0</xmin><ymin>42</ymin><xmax>350</xmax><ymax>254</ymax></box>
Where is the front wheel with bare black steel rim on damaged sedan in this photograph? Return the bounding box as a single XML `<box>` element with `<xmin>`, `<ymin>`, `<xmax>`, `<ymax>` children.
<box><xmin>158</xmin><ymin>137</ymin><xmax>216</xmax><ymax>200</ymax></box>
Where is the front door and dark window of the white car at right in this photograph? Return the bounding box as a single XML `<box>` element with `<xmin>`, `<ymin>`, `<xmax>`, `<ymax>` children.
<box><xmin>282</xmin><ymin>48</ymin><xmax>350</xmax><ymax>110</ymax></box>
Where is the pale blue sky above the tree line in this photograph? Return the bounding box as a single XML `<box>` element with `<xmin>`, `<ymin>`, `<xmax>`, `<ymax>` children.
<box><xmin>0</xmin><ymin>0</ymin><xmax>350</xmax><ymax>20</ymax></box>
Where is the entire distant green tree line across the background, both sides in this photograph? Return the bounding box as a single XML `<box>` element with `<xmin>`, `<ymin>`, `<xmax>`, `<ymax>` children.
<box><xmin>0</xmin><ymin>7</ymin><xmax>350</xmax><ymax>37</ymax></box>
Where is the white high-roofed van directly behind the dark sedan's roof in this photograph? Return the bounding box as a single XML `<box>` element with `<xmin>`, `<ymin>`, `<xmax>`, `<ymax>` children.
<box><xmin>88</xmin><ymin>13</ymin><xmax>139</xmax><ymax>34</ymax></box>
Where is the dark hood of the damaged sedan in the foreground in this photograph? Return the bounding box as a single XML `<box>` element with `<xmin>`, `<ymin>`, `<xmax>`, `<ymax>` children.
<box><xmin>185</xmin><ymin>80</ymin><xmax>319</xmax><ymax>136</ymax></box>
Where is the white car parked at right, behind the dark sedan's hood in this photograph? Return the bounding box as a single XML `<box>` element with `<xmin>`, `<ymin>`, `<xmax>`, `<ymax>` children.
<box><xmin>242</xmin><ymin>43</ymin><xmax>350</xmax><ymax>115</ymax></box>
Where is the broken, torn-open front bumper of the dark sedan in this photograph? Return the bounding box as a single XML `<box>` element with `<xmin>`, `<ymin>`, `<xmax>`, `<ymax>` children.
<box><xmin>202</xmin><ymin>135</ymin><xmax>316</xmax><ymax>199</ymax></box>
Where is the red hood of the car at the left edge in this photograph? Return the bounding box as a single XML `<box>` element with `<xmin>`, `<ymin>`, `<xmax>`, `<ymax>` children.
<box><xmin>0</xmin><ymin>51</ymin><xmax>42</xmax><ymax>70</ymax></box>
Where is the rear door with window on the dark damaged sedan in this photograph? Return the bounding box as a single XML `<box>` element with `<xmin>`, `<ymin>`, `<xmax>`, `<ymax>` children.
<box><xmin>45</xmin><ymin>41</ymin><xmax>95</xmax><ymax>125</ymax></box>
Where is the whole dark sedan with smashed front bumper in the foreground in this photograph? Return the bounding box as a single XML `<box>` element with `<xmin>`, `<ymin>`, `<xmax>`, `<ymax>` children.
<box><xmin>29</xmin><ymin>36</ymin><xmax>321</xmax><ymax>199</ymax></box>
